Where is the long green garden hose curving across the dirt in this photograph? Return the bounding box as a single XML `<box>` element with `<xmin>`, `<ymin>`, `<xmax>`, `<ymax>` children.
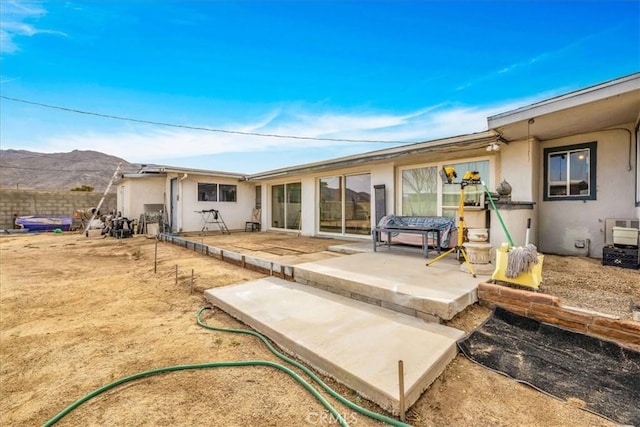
<box><xmin>43</xmin><ymin>307</ymin><xmax>410</xmax><ymax>427</ymax></box>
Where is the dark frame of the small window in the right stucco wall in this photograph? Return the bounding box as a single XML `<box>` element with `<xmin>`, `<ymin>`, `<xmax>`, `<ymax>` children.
<box><xmin>542</xmin><ymin>141</ymin><xmax>598</xmax><ymax>202</ymax></box>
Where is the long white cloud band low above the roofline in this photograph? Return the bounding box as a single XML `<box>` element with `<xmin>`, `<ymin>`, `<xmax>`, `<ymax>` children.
<box><xmin>30</xmin><ymin>102</ymin><xmax>536</xmax><ymax>166</ymax></box>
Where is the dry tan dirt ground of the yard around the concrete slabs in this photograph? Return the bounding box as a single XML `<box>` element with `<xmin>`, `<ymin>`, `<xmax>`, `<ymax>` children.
<box><xmin>0</xmin><ymin>233</ymin><xmax>640</xmax><ymax>427</ymax></box>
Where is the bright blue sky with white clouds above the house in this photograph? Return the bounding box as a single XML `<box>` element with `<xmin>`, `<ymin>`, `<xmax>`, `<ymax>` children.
<box><xmin>0</xmin><ymin>0</ymin><xmax>640</xmax><ymax>173</ymax></box>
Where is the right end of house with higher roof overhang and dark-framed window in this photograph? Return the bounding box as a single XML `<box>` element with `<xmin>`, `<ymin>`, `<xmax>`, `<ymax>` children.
<box><xmin>488</xmin><ymin>73</ymin><xmax>640</xmax><ymax>257</ymax></box>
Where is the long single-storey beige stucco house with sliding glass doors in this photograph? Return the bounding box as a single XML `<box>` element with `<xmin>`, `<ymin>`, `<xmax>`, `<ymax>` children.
<box><xmin>118</xmin><ymin>73</ymin><xmax>640</xmax><ymax>258</ymax></box>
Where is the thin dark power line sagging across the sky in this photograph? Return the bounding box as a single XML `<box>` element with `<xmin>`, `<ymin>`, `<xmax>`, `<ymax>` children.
<box><xmin>0</xmin><ymin>95</ymin><xmax>409</xmax><ymax>144</ymax></box>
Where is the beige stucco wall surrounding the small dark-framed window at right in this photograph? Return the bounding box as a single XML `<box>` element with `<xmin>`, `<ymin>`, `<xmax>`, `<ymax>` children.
<box><xmin>536</xmin><ymin>124</ymin><xmax>638</xmax><ymax>258</ymax></box>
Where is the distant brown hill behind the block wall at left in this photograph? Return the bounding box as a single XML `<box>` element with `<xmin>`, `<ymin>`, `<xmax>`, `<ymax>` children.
<box><xmin>0</xmin><ymin>150</ymin><xmax>140</xmax><ymax>192</ymax></box>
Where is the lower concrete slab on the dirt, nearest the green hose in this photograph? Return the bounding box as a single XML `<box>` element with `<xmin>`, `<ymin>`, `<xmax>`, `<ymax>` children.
<box><xmin>205</xmin><ymin>280</ymin><xmax>464</xmax><ymax>415</ymax></box>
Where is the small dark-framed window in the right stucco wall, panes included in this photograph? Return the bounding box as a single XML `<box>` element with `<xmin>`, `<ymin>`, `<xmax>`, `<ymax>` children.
<box><xmin>544</xmin><ymin>142</ymin><xmax>597</xmax><ymax>201</ymax></box>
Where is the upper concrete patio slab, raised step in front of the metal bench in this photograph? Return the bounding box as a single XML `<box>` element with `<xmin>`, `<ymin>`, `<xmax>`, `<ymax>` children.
<box><xmin>293</xmin><ymin>251</ymin><xmax>482</xmax><ymax>322</ymax></box>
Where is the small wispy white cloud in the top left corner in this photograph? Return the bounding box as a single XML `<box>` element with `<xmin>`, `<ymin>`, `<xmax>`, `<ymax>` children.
<box><xmin>0</xmin><ymin>1</ymin><xmax>66</xmax><ymax>54</ymax></box>
